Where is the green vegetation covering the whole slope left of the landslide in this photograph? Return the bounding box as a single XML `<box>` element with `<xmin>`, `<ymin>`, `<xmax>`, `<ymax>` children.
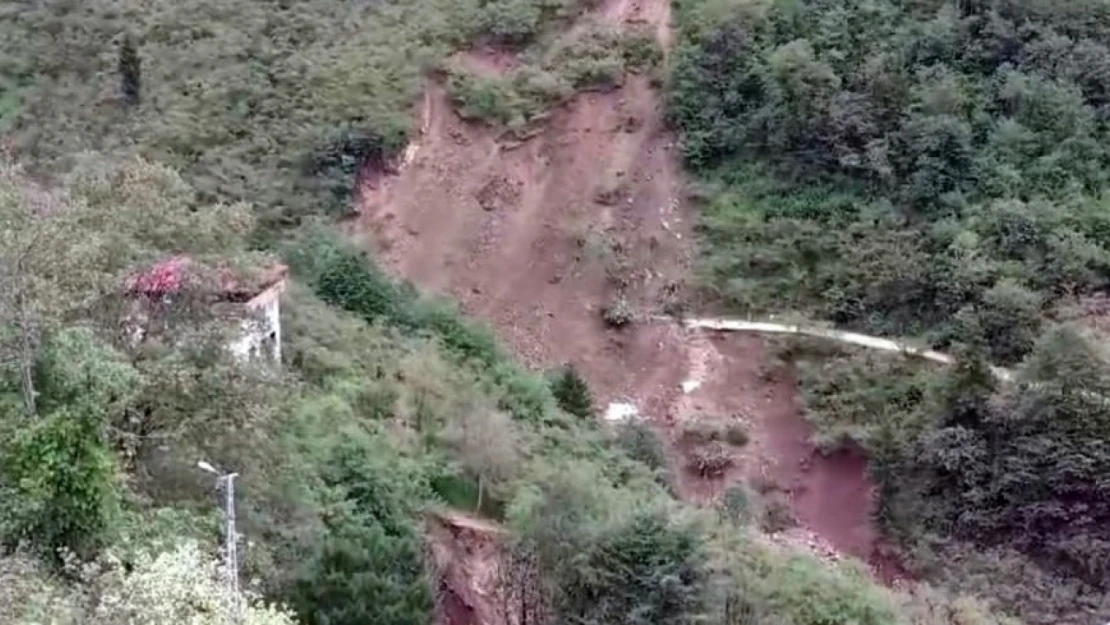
<box><xmin>0</xmin><ymin>0</ymin><xmax>1021</xmax><ymax>625</ymax></box>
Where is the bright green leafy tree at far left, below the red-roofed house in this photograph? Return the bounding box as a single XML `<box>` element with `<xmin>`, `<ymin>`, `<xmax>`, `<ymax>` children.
<box><xmin>0</xmin><ymin>327</ymin><xmax>138</xmax><ymax>557</ymax></box>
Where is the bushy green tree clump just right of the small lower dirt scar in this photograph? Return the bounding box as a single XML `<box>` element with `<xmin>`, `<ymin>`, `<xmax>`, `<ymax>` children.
<box><xmin>508</xmin><ymin>466</ymin><xmax>706</xmax><ymax>625</ymax></box>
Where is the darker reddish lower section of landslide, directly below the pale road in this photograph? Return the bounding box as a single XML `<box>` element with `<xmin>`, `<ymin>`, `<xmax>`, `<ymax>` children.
<box><xmin>672</xmin><ymin>330</ymin><xmax>905</xmax><ymax>583</ymax></box>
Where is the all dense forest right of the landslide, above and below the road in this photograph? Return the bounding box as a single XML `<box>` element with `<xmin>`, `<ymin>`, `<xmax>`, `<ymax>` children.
<box><xmin>669</xmin><ymin>0</ymin><xmax>1110</xmax><ymax>623</ymax></box>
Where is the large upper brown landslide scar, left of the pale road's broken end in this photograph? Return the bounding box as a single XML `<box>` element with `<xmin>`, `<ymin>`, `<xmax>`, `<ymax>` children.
<box><xmin>361</xmin><ymin>72</ymin><xmax>688</xmax><ymax>412</ymax></box>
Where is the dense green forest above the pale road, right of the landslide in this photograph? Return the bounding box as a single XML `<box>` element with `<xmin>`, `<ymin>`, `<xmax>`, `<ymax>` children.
<box><xmin>672</xmin><ymin>0</ymin><xmax>1110</xmax><ymax>364</ymax></box>
